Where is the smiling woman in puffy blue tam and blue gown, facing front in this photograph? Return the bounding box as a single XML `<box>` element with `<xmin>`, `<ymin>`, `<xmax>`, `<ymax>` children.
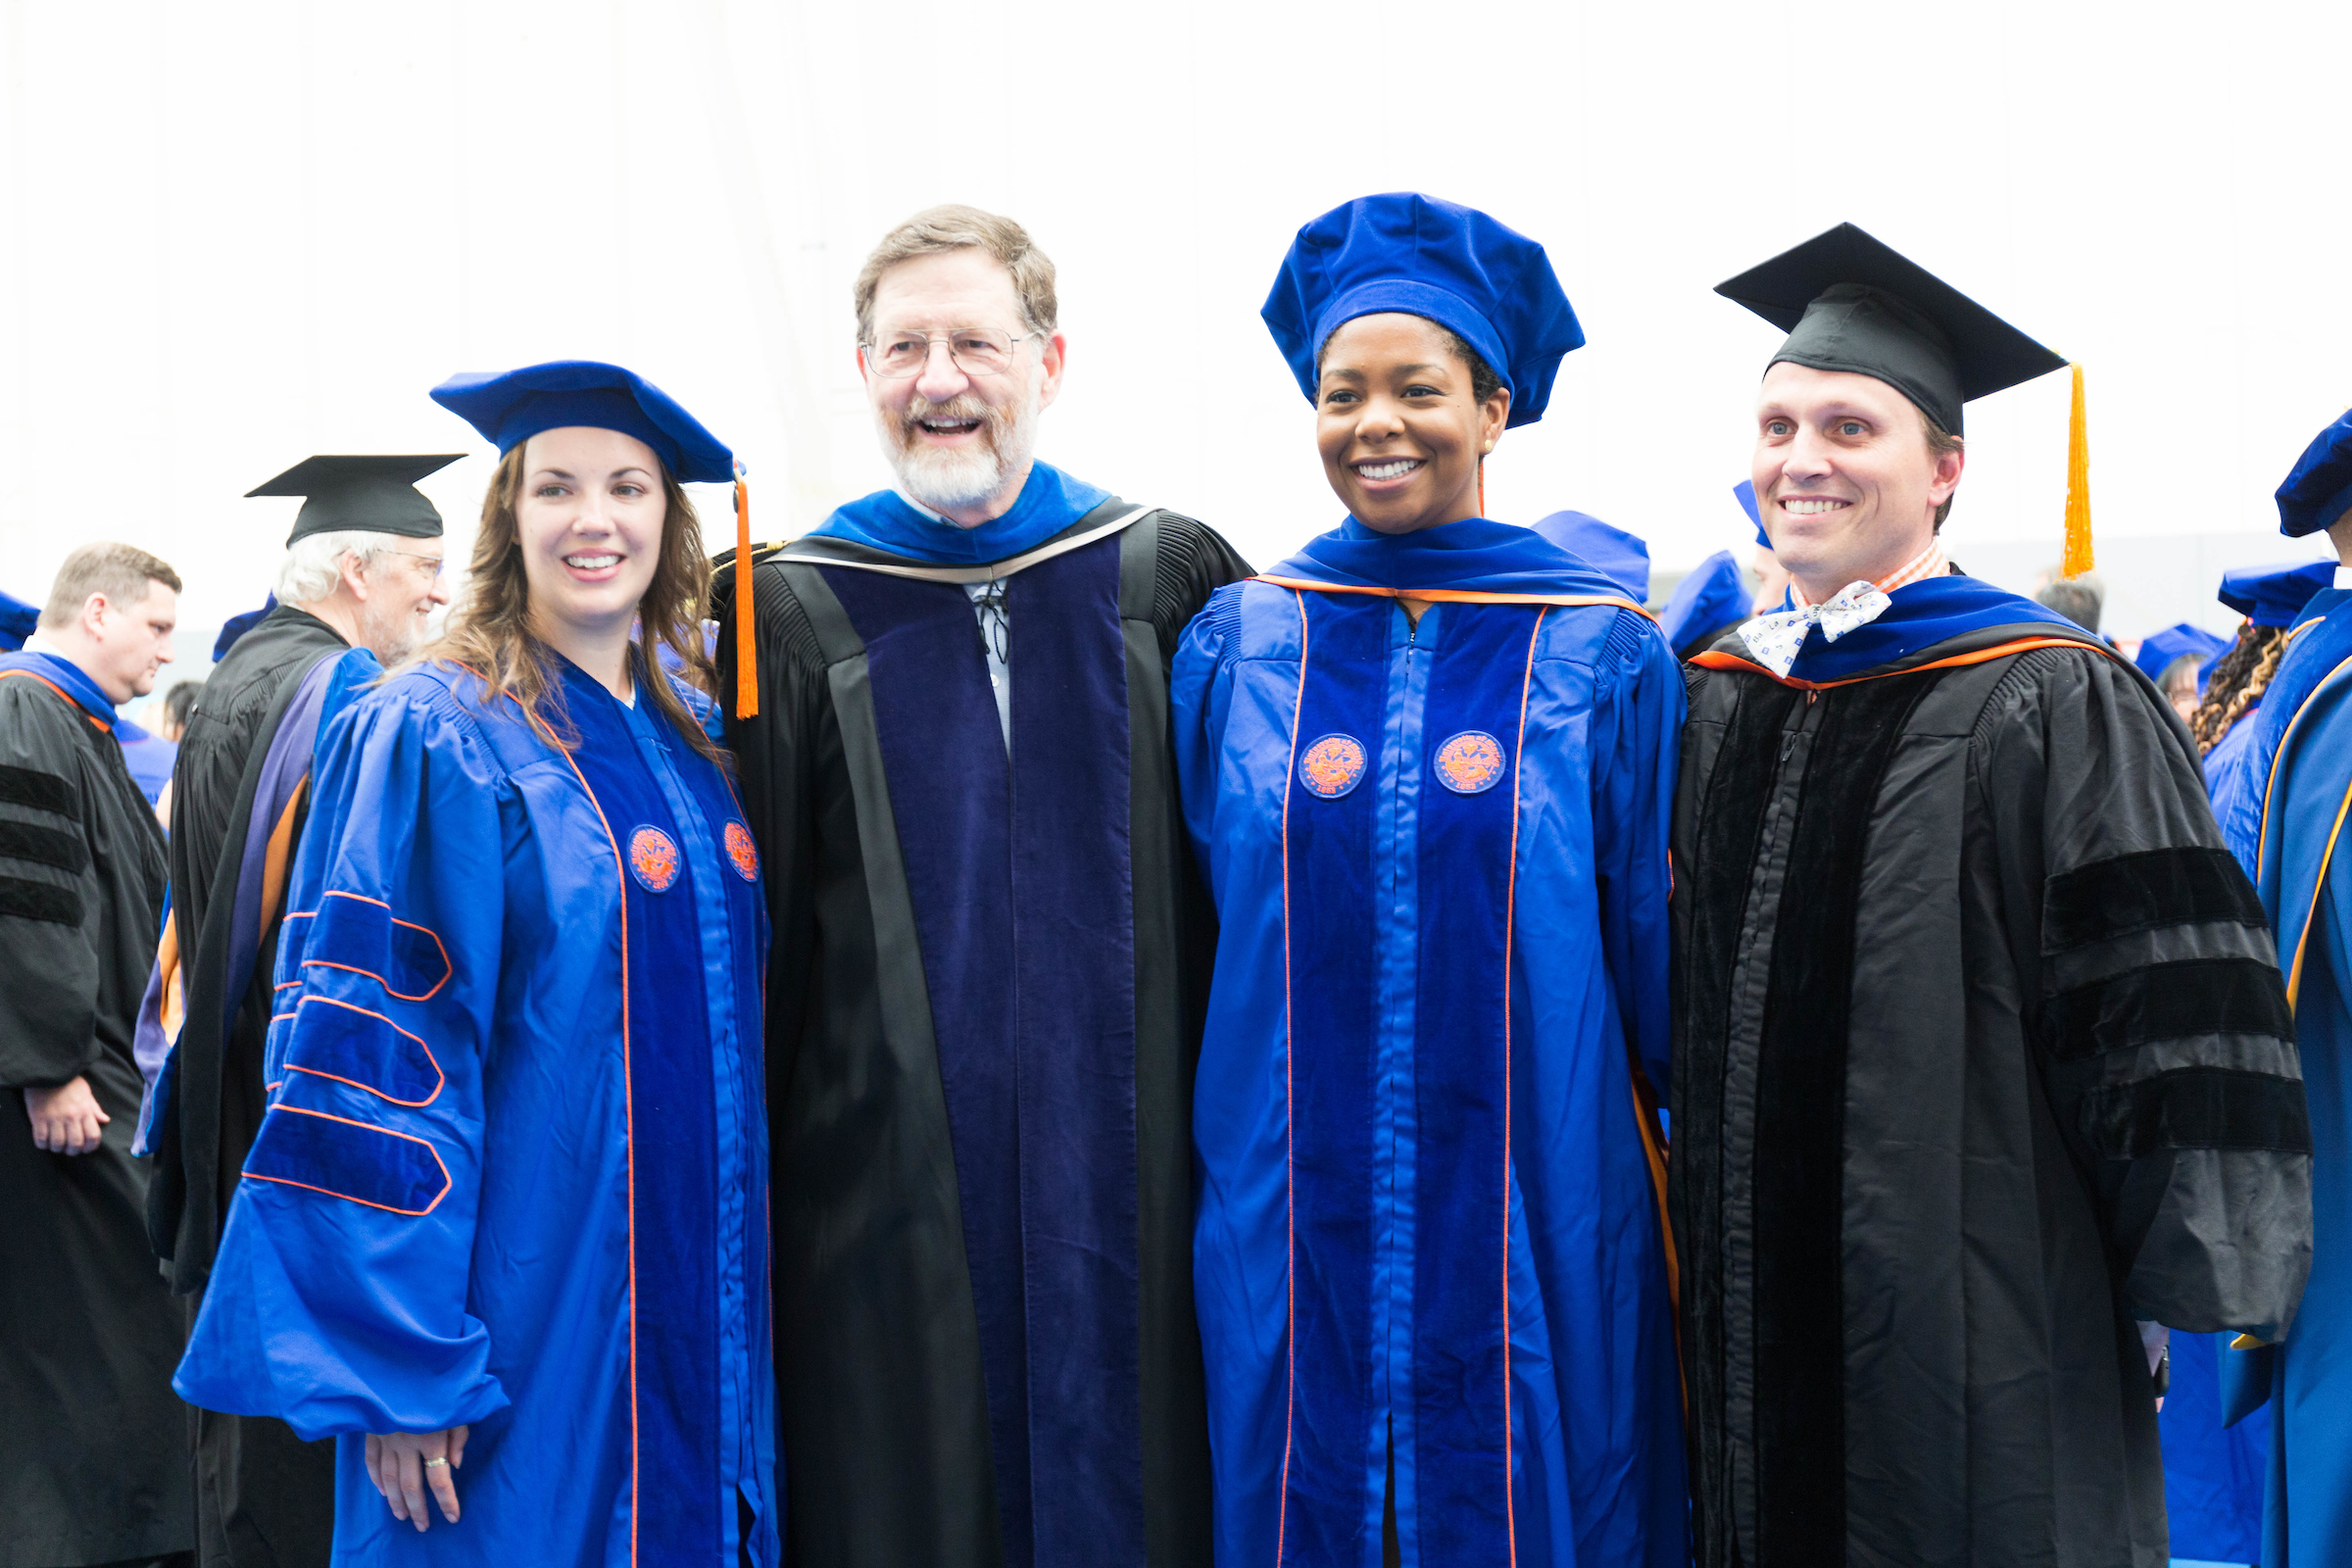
<box><xmin>1174</xmin><ymin>195</ymin><xmax>1689</xmax><ymax>1568</ymax></box>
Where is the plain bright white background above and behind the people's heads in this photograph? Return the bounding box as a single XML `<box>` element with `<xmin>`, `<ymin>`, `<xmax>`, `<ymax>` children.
<box><xmin>0</xmin><ymin>0</ymin><xmax>2352</xmax><ymax>682</ymax></box>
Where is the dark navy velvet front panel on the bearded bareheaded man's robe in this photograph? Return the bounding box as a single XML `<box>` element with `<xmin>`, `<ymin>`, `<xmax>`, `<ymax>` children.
<box><xmin>825</xmin><ymin>538</ymin><xmax>1143</xmax><ymax>1568</ymax></box>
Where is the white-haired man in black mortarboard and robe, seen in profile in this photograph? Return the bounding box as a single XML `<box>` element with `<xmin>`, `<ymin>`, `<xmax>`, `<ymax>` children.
<box><xmin>139</xmin><ymin>454</ymin><xmax>459</xmax><ymax>1568</ymax></box>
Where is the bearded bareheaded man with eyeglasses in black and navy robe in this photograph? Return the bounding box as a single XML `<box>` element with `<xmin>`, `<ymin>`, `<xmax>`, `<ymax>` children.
<box><xmin>715</xmin><ymin>207</ymin><xmax>1249</xmax><ymax>1568</ymax></box>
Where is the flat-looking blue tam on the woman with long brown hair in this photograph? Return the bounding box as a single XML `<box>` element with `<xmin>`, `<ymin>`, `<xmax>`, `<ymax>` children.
<box><xmin>433</xmin><ymin>360</ymin><xmax>736</xmax><ymax>484</ymax></box>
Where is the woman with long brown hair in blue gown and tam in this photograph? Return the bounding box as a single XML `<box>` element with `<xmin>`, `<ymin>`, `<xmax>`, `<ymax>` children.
<box><xmin>176</xmin><ymin>362</ymin><xmax>778</xmax><ymax>1566</ymax></box>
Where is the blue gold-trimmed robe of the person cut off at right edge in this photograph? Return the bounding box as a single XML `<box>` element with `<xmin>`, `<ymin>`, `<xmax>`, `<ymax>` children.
<box><xmin>2223</xmin><ymin>590</ymin><xmax>2352</xmax><ymax>1568</ymax></box>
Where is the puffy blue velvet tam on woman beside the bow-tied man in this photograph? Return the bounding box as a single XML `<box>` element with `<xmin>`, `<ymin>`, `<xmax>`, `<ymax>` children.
<box><xmin>1258</xmin><ymin>190</ymin><xmax>1586</xmax><ymax>425</ymax></box>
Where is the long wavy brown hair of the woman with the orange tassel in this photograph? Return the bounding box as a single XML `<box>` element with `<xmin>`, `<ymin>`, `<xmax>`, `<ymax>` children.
<box><xmin>416</xmin><ymin>442</ymin><xmax>727</xmax><ymax>766</ymax></box>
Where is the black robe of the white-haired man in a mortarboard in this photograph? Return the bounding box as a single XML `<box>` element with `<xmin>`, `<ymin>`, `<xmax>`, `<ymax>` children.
<box><xmin>148</xmin><ymin>604</ymin><xmax>351</xmax><ymax>1568</ymax></box>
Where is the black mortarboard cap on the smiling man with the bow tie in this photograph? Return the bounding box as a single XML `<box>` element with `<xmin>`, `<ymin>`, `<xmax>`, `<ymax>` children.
<box><xmin>1715</xmin><ymin>223</ymin><xmax>2065</xmax><ymax>435</ymax></box>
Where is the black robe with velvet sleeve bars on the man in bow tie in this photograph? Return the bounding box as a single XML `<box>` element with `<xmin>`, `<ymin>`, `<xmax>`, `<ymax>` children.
<box><xmin>1670</xmin><ymin>606</ymin><xmax>2310</xmax><ymax>1568</ymax></box>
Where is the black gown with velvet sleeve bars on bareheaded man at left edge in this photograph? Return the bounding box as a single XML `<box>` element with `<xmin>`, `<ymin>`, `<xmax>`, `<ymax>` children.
<box><xmin>0</xmin><ymin>674</ymin><xmax>190</xmax><ymax>1568</ymax></box>
